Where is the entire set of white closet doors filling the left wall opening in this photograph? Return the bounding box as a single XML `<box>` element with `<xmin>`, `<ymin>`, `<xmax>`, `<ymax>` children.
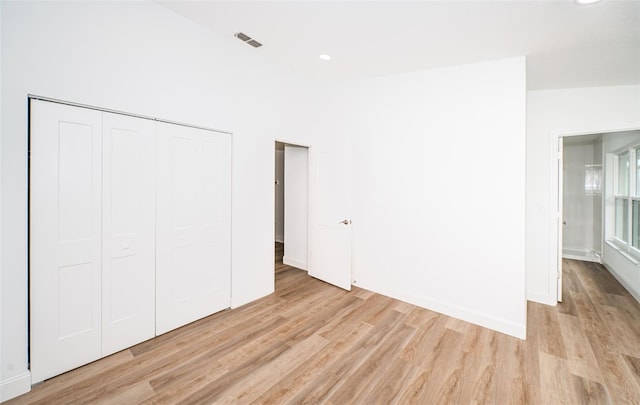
<box><xmin>29</xmin><ymin>100</ymin><xmax>231</xmax><ymax>383</ymax></box>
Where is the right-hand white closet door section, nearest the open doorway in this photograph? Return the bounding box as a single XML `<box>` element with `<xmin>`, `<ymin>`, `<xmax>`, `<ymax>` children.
<box><xmin>156</xmin><ymin>123</ymin><xmax>231</xmax><ymax>334</ymax></box>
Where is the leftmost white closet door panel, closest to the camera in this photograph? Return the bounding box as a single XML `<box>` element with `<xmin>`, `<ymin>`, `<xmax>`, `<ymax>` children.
<box><xmin>29</xmin><ymin>101</ymin><xmax>102</xmax><ymax>383</ymax></box>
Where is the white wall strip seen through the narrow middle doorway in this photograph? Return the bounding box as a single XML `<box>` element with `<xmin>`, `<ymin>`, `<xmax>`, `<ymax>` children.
<box><xmin>282</xmin><ymin>145</ymin><xmax>309</xmax><ymax>270</ymax></box>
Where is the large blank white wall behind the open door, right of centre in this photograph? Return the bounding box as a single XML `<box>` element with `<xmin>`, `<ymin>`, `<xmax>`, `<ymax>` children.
<box><xmin>322</xmin><ymin>58</ymin><xmax>526</xmax><ymax>337</ymax></box>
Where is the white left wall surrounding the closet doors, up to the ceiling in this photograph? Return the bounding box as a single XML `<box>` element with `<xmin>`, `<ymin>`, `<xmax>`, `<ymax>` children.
<box><xmin>0</xmin><ymin>1</ymin><xmax>315</xmax><ymax>399</ymax></box>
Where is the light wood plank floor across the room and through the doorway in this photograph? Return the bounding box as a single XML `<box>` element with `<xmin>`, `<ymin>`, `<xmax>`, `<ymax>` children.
<box><xmin>9</xmin><ymin>248</ymin><xmax>640</xmax><ymax>405</ymax></box>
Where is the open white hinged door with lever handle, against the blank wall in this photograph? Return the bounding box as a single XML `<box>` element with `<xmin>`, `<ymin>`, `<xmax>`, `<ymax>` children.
<box><xmin>309</xmin><ymin>143</ymin><xmax>352</xmax><ymax>290</ymax></box>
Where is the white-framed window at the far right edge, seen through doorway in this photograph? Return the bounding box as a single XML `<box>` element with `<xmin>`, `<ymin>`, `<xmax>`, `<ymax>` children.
<box><xmin>613</xmin><ymin>147</ymin><xmax>640</xmax><ymax>252</ymax></box>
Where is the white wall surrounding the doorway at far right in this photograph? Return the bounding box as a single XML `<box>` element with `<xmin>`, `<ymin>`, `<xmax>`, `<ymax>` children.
<box><xmin>526</xmin><ymin>86</ymin><xmax>640</xmax><ymax>305</ymax></box>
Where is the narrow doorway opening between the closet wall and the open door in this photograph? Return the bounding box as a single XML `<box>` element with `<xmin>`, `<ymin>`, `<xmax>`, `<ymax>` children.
<box><xmin>274</xmin><ymin>141</ymin><xmax>309</xmax><ymax>273</ymax></box>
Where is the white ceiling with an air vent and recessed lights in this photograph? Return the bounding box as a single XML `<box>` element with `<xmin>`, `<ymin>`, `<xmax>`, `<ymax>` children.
<box><xmin>158</xmin><ymin>0</ymin><xmax>640</xmax><ymax>90</ymax></box>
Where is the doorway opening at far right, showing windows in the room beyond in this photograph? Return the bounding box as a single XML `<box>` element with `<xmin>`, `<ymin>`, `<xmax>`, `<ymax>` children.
<box><xmin>557</xmin><ymin>130</ymin><xmax>640</xmax><ymax>302</ymax></box>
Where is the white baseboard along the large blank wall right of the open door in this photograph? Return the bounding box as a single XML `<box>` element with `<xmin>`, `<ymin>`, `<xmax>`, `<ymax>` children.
<box><xmin>358</xmin><ymin>283</ymin><xmax>527</xmax><ymax>339</ymax></box>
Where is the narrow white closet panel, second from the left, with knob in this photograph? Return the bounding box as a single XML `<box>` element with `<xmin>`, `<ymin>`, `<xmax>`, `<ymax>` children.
<box><xmin>102</xmin><ymin>113</ymin><xmax>156</xmax><ymax>356</ymax></box>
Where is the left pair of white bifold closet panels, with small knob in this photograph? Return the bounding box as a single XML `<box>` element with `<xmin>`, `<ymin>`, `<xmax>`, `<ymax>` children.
<box><xmin>29</xmin><ymin>100</ymin><xmax>156</xmax><ymax>382</ymax></box>
